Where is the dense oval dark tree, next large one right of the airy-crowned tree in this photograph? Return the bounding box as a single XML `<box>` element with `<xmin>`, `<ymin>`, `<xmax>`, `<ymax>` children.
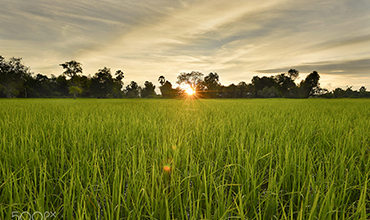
<box><xmin>90</xmin><ymin>67</ymin><xmax>114</xmax><ymax>98</ymax></box>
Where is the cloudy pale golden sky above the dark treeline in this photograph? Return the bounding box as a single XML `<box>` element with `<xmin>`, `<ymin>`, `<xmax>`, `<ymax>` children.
<box><xmin>0</xmin><ymin>0</ymin><xmax>370</xmax><ymax>91</ymax></box>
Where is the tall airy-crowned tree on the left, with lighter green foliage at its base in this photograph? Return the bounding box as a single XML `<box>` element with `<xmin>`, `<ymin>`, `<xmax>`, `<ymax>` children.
<box><xmin>59</xmin><ymin>60</ymin><xmax>82</xmax><ymax>99</ymax></box>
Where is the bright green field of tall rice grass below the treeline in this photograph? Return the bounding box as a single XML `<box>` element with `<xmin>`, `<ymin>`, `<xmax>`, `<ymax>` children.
<box><xmin>0</xmin><ymin>99</ymin><xmax>370</xmax><ymax>220</ymax></box>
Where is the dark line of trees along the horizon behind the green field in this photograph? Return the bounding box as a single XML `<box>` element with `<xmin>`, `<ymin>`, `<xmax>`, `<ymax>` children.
<box><xmin>0</xmin><ymin>56</ymin><xmax>370</xmax><ymax>98</ymax></box>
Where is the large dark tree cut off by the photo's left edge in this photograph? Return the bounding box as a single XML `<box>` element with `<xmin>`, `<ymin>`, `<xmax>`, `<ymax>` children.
<box><xmin>0</xmin><ymin>56</ymin><xmax>31</xmax><ymax>98</ymax></box>
